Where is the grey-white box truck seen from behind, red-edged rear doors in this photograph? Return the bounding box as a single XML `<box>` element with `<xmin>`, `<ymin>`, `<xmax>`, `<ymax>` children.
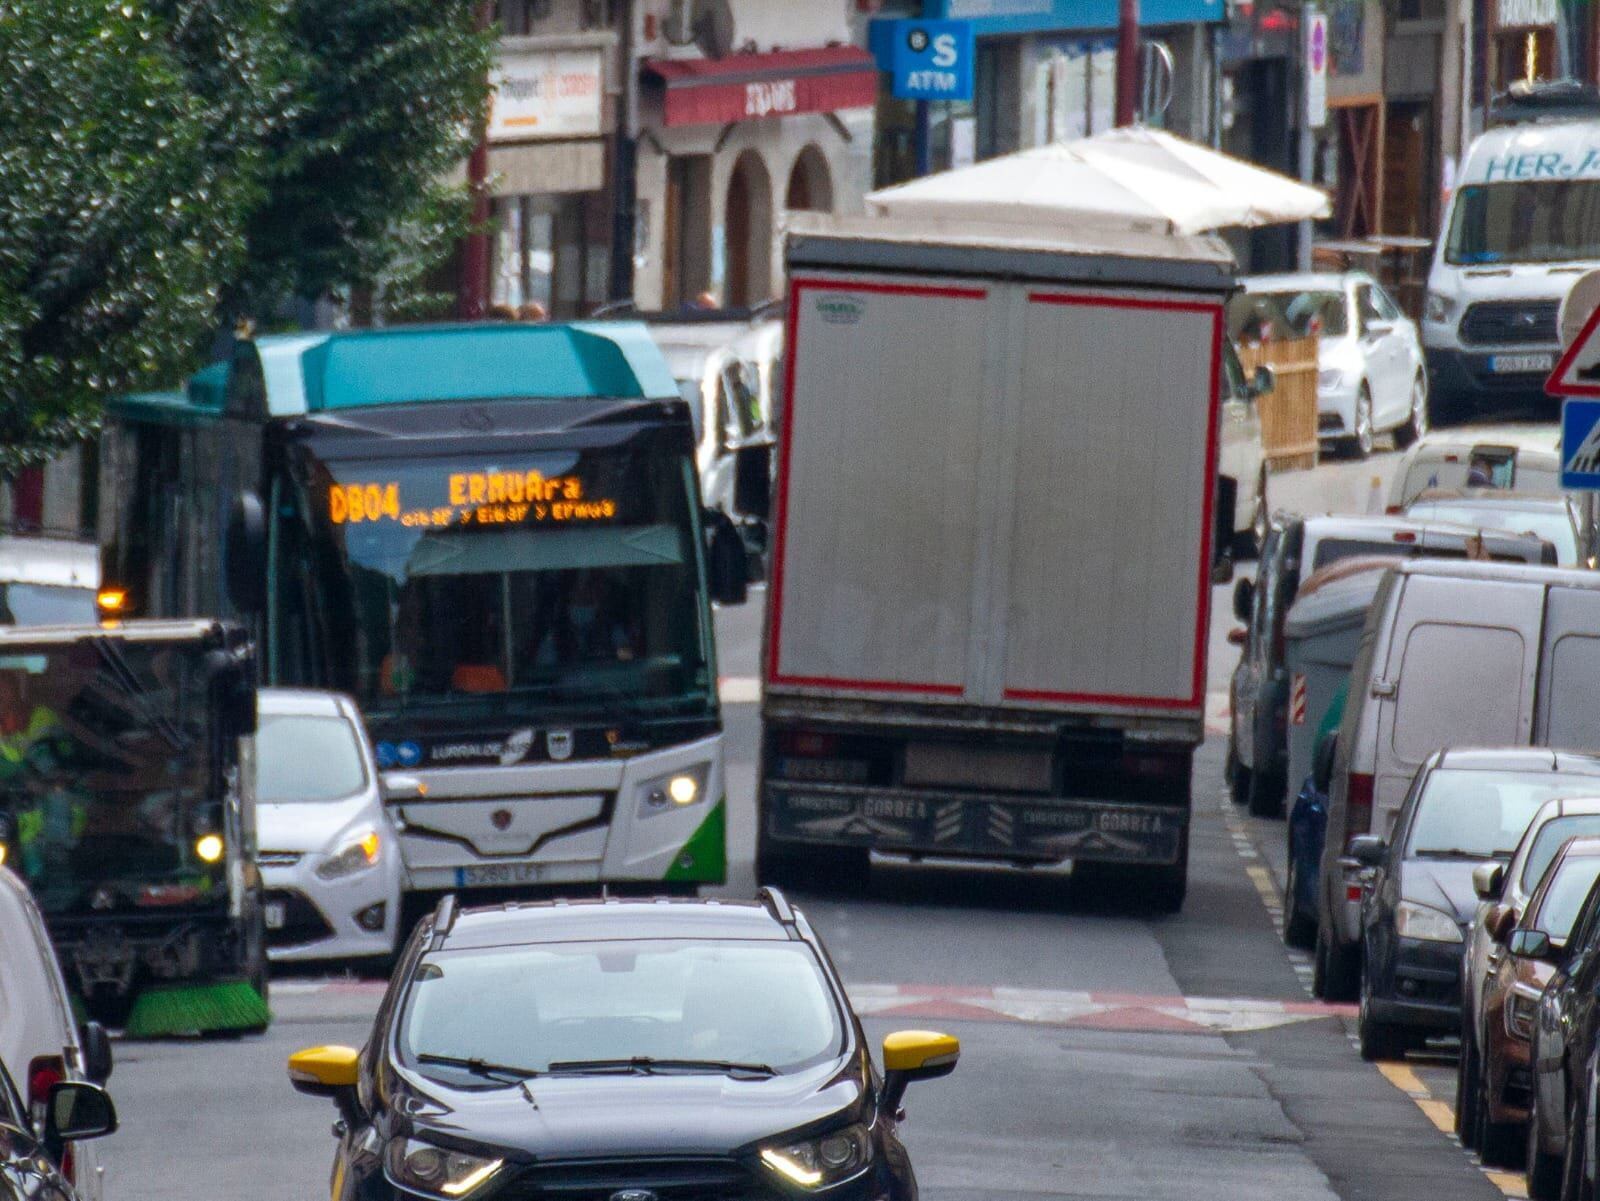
<box><xmin>757</xmin><ymin>219</ymin><xmax>1235</xmax><ymax>910</ymax></box>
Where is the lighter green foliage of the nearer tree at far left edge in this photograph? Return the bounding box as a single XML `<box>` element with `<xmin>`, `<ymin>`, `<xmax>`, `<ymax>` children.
<box><xmin>0</xmin><ymin>0</ymin><xmax>250</xmax><ymax>475</ymax></box>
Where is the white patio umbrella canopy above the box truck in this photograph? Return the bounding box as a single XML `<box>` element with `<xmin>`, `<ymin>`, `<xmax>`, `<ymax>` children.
<box><xmin>867</xmin><ymin>126</ymin><xmax>1328</xmax><ymax>233</ymax></box>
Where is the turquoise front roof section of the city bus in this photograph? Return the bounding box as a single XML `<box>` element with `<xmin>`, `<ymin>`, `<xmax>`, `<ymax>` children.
<box><xmin>249</xmin><ymin>321</ymin><xmax>682</xmax><ymax>417</ymax></box>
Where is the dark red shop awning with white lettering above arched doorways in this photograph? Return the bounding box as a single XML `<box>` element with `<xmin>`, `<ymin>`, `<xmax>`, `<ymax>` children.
<box><xmin>645</xmin><ymin>46</ymin><xmax>878</xmax><ymax>125</ymax></box>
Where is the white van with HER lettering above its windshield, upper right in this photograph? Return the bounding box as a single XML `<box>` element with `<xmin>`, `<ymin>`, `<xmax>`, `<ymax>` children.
<box><xmin>1422</xmin><ymin>120</ymin><xmax>1600</xmax><ymax>419</ymax></box>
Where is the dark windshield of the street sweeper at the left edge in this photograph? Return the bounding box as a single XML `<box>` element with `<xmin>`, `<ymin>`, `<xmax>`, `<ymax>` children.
<box><xmin>0</xmin><ymin>638</ymin><xmax>222</xmax><ymax>912</ymax></box>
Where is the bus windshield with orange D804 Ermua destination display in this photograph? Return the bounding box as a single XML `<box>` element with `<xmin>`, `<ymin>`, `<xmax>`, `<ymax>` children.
<box><xmin>310</xmin><ymin>438</ymin><xmax>712</xmax><ymax>716</ymax></box>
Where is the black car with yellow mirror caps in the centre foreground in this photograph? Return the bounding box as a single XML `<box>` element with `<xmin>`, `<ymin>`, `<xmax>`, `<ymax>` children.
<box><xmin>290</xmin><ymin>889</ymin><xmax>960</xmax><ymax>1201</ymax></box>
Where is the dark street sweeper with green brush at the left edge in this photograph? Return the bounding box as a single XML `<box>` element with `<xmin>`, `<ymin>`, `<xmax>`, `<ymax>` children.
<box><xmin>0</xmin><ymin>620</ymin><xmax>269</xmax><ymax>1036</ymax></box>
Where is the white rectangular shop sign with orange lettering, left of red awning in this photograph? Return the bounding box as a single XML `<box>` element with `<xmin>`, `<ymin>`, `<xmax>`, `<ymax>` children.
<box><xmin>490</xmin><ymin>50</ymin><xmax>605</xmax><ymax>142</ymax></box>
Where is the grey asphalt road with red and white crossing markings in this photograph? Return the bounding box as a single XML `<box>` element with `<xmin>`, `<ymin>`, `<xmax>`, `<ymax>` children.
<box><xmin>90</xmin><ymin>428</ymin><xmax>1536</xmax><ymax>1201</ymax></box>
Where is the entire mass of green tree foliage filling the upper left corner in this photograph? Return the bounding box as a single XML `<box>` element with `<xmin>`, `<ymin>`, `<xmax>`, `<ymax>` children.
<box><xmin>0</xmin><ymin>0</ymin><xmax>494</xmax><ymax>477</ymax></box>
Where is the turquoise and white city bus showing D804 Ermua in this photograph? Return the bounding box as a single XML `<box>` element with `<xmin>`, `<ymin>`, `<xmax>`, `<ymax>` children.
<box><xmin>101</xmin><ymin>323</ymin><xmax>746</xmax><ymax>904</ymax></box>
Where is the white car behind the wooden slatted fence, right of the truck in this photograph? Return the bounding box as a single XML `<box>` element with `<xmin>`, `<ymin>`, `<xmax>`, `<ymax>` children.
<box><xmin>1229</xmin><ymin>272</ymin><xmax>1427</xmax><ymax>457</ymax></box>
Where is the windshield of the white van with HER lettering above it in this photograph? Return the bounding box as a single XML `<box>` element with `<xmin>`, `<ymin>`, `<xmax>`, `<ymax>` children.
<box><xmin>1445</xmin><ymin>179</ymin><xmax>1600</xmax><ymax>267</ymax></box>
